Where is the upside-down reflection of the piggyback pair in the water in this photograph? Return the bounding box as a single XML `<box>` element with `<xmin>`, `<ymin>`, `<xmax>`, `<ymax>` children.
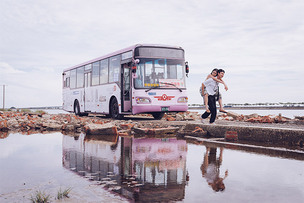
<box><xmin>201</xmin><ymin>147</ymin><xmax>228</xmax><ymax>192</ymax></box>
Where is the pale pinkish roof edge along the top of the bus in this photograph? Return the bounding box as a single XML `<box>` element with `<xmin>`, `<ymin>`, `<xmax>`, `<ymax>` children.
<box><xmin>63</xmin><ymin>44</ymin><xmax>183</xmax><ymax>72</ymax></box>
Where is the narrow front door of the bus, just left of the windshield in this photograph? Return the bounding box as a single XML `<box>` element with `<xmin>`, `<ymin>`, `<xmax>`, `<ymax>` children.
<box><xmin>121</xmin><ymin>64</ymin><xmax>131</xmax><ymax>112</ymax></box>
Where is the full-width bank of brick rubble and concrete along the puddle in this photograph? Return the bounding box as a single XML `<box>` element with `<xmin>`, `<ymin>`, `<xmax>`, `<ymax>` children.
<box><xmin>0</xmin><ymin>111</ymin><xmax>304</xmax><ymax>147</ymax></box>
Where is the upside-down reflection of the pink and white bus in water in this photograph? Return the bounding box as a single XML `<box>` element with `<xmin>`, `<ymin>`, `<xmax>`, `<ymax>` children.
<box><xmin>63</xmin><ymin>134</ymin><xmax>187</xmax><ymax>201</ymax></box>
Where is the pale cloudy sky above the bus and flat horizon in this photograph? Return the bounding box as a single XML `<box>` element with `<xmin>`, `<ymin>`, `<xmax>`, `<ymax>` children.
<box><xmin>0</xmin><ymin>0</ymin><xmax>304</xmax><ymax>108</ymax></box>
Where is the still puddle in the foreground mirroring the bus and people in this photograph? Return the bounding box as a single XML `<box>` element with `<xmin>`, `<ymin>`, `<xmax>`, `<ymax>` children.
<box><xmin>0</xmin><ymin>133</ymin><xmax>304</xmax><ymax>202</ymax></box>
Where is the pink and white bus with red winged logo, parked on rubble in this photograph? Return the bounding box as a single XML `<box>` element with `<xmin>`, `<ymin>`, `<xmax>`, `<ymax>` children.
<box><xmin>62</xmin><ymin>44</ymin><xmax>189</xmax><ymax>119</ymax></box>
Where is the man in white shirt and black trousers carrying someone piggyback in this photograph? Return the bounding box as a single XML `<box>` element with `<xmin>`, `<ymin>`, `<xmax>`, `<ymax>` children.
<box><xmin>201</xmin><ymin>69</ymin><xmax>225</xmax><ymax>124</ymax></box>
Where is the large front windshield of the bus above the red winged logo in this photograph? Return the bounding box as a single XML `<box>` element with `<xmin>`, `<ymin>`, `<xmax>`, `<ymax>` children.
<box><xmin>134</xmin><ymin>58</ymin><xmax>186</xmax><ymax>89</ymax></box>
